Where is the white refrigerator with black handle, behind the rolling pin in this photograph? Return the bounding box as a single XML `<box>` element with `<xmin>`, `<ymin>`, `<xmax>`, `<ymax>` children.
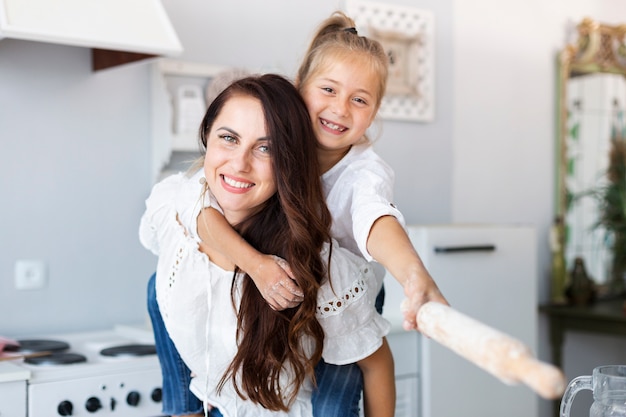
<box><xmin>383</xmin><ymin>225</ymin><xmax>538</xmax><ymax>417</ymax></box>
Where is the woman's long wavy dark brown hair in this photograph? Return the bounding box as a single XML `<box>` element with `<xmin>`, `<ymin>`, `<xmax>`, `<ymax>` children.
<box><xmin>200</xmin><ymin>74</ymin><xmax>331</xmax><ymax>411</ymax></box>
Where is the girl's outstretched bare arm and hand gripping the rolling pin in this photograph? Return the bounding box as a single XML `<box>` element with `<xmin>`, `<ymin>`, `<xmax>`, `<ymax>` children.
<box><xmin>367</xmin><ymin>216</ymin><xmax>448</xmax><ymax>330</ymax></box>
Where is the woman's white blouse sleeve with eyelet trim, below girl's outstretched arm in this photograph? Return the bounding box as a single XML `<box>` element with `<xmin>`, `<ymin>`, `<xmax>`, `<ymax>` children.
<box><xmin>317</xmin><ymin>240</ymin><xmax>391</xmax><ymax>365</ymax></box>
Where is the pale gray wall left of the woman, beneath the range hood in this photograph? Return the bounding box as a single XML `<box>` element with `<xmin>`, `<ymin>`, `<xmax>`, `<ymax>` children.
<box><xmin>0</xmin><ymin>39</ymin><xmax>154</xmax><ymax>335</ymax></box>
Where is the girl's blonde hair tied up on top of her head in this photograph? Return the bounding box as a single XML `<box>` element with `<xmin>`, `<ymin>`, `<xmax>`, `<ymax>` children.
<box><xmin>296</xmin><ymin>11</ymin><xmax>389</xmax><ymax>111</ymax></box>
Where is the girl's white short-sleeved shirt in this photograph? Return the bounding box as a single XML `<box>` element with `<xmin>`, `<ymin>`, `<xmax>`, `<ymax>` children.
<box><xmin>322</xmin><ymin>143</ymin><xmax>405</xmax><ymax>261</ymax></box>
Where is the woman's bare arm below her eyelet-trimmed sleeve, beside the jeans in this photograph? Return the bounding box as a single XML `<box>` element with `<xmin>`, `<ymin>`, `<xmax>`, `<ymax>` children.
<box><xmin>358</xmin><ymin>338</ymin><xmax>396</xmax><ymax>417</ymax></box>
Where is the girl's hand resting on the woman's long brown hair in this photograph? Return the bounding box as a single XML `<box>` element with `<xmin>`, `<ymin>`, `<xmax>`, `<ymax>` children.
<box><xmin>249</xmin><ymin>255</ymin><xmax>304</xmax><ymax>311</ymax></box>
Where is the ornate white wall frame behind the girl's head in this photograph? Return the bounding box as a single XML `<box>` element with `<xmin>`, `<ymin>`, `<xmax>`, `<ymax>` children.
<box><xmin>346</xmin><ymin>0</ymin><xmax>435</xmax><ymax>122</ymax></box>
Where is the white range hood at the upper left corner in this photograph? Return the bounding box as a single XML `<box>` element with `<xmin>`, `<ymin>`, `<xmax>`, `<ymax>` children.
<box><xmin>0</xmin><ymin>0</ymin><xmax>183</xmax><ymax>55</ymax></box>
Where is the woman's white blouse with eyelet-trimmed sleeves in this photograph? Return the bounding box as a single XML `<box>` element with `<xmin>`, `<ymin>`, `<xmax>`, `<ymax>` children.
<box><xmin>139</xmin><ymin>171</ymin><xmax>390</xmax><ymax>417</ymax></box>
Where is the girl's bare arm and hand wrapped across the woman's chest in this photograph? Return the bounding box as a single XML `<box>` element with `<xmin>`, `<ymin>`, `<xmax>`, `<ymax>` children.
<box><xmin>201</xmin><ymin>207</ymin><xmax>302</xmax><ymax>310</ymax></box>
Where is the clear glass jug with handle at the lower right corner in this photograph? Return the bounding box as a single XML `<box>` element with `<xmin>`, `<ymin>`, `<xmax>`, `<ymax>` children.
<box><xmin>559</xmin><ymin>365</ymin><xmax>626</xmax><ymax>417</ymax></box>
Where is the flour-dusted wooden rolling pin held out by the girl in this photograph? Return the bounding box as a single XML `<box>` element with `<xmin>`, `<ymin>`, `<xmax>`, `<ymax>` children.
<box><xmin>416</xmin><ymin>301</ymin><xmax>567</xmax><ymax>399</ymax></box>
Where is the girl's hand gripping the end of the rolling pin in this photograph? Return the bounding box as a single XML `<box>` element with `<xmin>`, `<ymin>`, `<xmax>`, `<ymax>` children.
<box><xmin>400</xmin><ymin>275</ymin><xmax>449</xmax><ymax>331</ymax></box>
